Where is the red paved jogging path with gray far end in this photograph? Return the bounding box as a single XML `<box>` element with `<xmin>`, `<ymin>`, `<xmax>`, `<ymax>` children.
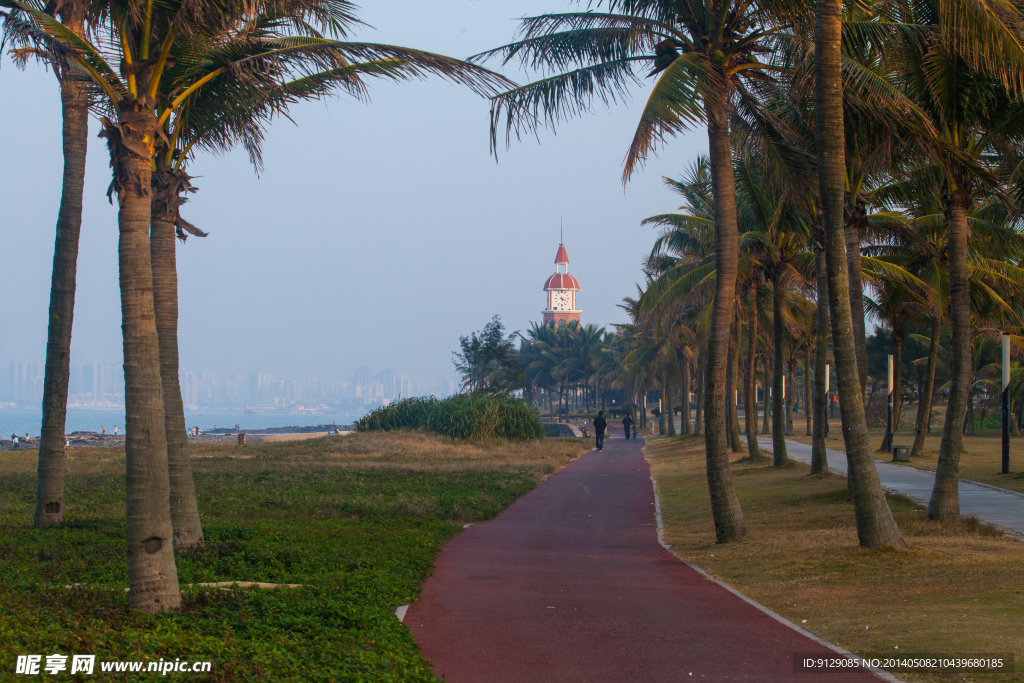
<box><xmin>404</xmin><ymin>438</ymin><xmax>879</xmax><ymax>683</ymax></box>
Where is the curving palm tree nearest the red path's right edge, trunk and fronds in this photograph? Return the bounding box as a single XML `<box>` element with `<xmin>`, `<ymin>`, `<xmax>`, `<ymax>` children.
<box><xmin>479</xmin><ymin>0</ymin><xmax>815</xmax><ymax>542</ymax></box>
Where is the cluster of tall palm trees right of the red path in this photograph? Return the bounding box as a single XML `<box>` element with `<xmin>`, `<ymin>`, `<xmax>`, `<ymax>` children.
<box><xmin>480</xmin><ymin>0</ymin><xmax>1024</xmax><ymax>549</ymax></box>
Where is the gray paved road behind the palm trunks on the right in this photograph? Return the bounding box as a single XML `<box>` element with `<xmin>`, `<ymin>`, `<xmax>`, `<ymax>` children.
<box><xmin>743</xmin><ymin>436</ymin><xmax>1024</xmax><ymax>536</ymax></box>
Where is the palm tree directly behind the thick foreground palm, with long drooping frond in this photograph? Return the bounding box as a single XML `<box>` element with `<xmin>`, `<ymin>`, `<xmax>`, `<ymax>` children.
<box><xmin>143</xmin><ymin>12</ymin><xmax>506</xmax><ymax>550</ymax></box>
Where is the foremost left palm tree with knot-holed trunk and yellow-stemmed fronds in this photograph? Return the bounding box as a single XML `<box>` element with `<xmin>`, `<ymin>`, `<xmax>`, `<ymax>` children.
<box><xmin>15</xmin><ymin>0</ymin><xmax>516</xmax><ymax>611</ymax></box>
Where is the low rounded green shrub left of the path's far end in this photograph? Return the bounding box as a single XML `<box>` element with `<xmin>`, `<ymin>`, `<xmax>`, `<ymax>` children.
<box><xmin>355</xmin><ymin>394</ymin><xmax>544</xmax><ymax>441</ymax></box>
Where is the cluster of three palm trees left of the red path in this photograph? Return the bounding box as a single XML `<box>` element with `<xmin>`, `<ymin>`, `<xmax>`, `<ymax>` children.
<box><xmin>0</xmin><ymin>0</ymin><xmax>511</xmax><ymax>611</ymax></box>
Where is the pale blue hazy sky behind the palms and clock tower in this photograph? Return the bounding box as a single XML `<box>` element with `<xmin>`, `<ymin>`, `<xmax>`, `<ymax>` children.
<box><xmin>0</xmin><ymin>0</ymin><xmax>707</xmax><ymax>379</ymax></box>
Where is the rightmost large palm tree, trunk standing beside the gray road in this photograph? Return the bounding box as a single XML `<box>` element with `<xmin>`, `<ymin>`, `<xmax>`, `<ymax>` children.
<box><xmin>898</xmin><ymin>0</ymin><xmax>1024</xmax><ymax>519</ymax></box>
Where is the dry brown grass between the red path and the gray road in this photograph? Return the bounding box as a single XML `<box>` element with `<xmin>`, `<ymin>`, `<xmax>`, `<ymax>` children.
<box><xmin>647</xmin><ymin>437</ymin><xmax>1024</xmax><ymax>681</ymax></box>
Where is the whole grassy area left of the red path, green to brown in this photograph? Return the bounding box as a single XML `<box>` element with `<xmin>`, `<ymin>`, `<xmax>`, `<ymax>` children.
<box><xmin>0</xmin><ymin>432</ymin><xmax>588</xmax><ymax>681</ymax></box>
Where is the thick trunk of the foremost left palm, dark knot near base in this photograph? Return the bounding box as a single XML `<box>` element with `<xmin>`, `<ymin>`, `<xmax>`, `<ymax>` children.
<box><xmin>104</xmin><ymin>103</ymin><xmax>181</xmax><ymax>612</ymax></box>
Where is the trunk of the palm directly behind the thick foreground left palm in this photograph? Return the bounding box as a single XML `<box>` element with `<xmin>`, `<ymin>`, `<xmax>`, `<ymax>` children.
<box><xmin>150</xmin><ymin>201</ymin><xmax>203</xmax><ymax>552</ymax></box>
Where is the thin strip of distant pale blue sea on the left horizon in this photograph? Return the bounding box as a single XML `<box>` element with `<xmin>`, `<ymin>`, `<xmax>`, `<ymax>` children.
<box><xmin>0</xmin><ymin>408</ymin><xmax>362</xmax><ymax>438</ymax></box>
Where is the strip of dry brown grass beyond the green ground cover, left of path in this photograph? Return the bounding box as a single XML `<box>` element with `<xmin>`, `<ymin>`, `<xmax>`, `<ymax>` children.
<box><xmin>0</xmin><ymin>432</ymin><xmax>590</xmax><ymax>480</ymax></box>
